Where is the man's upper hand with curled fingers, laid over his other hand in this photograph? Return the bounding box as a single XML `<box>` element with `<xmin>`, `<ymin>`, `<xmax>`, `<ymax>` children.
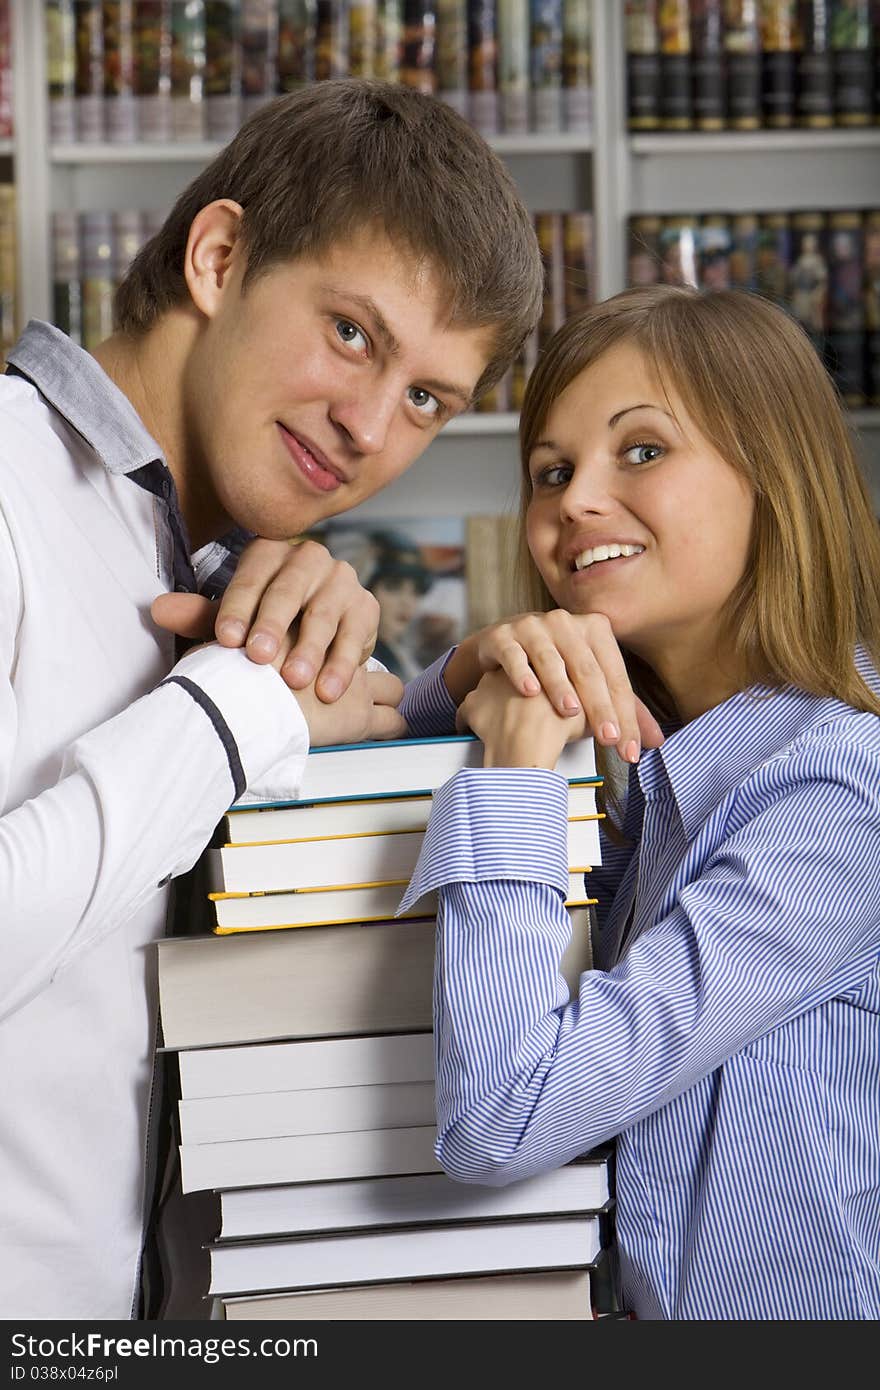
<box><xmin>150</xmin><ymin>539</ymin><xmax>380</xmax><ymax>703</ymax></box>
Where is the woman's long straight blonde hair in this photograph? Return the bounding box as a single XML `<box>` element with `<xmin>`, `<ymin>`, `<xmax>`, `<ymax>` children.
<box><xmin>520</xmin><ymin>285</ymin><xmax>880</xmax><ymax>717</ymax></box>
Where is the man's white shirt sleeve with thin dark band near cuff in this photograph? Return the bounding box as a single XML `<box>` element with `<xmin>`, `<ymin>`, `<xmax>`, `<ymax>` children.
<box><xmin>0</xmin><ymin>517</ymin><xmax>309</xmax><ymax>1016</ymax></box>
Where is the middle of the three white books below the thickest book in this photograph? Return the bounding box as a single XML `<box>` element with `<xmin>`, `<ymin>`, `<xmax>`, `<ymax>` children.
<box><xmin>179</xmin><ymin>1077</ymin><xmax>435</xmax><ymax>1148</ymax></box>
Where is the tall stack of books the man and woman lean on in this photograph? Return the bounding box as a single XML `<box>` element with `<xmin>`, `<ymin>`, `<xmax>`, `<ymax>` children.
<box><xmin>158</xmin><ymin>737</ymin><xmax>612</xmax><ymax>1319</ymax></box>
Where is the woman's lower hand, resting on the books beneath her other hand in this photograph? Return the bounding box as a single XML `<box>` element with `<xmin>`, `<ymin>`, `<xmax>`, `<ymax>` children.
<box><xmin>456</xmin><ymin>670</ymin><xmax>588</xmax><ymax>770</ymax></box>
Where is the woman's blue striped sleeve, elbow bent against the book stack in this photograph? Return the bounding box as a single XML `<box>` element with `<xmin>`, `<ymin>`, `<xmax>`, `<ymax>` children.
<box><xmin>410</xmin><ymin>748</ymin><xmax>880</xmax><ymax>1184</ymax></box>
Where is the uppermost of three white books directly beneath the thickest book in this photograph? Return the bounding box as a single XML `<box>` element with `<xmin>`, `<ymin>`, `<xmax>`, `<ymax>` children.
<box><xmin>178</xmin><ymin>1033</ymin><xmax>434</xmax><ymax>1099</ymax></box>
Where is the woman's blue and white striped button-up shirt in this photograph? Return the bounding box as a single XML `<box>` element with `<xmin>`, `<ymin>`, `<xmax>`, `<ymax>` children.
<box><xmin>402</xmin><ymin>647</ymin><xmax>880</xmax><ymax>1319</ymax></box>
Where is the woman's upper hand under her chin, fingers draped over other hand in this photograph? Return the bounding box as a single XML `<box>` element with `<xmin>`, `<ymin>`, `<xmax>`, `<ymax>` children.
<box><xmin>443</xmin><ymin>609</ymin><xmax>663</xmax><ymax>763</ymax></box>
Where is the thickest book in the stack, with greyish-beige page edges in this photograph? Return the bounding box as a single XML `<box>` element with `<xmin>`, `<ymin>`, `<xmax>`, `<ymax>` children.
<box><xmin>157</xmin><ymin>899</ymin><xmax>591</xmax><ymax>1049</ymax></box>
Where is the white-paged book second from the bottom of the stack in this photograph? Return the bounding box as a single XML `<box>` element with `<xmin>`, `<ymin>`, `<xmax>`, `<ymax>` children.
<box><xmin>209</xmin><ymin>1216</ymin><xmax>602</xmax><ymax>1294</ymax></box>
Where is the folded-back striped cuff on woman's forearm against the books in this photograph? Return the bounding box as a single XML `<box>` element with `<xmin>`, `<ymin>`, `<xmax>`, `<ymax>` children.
<box><xmin>398</xmin><ymin>767</ymin><xmax>569</xmax><ymax>912</ymax></box>
